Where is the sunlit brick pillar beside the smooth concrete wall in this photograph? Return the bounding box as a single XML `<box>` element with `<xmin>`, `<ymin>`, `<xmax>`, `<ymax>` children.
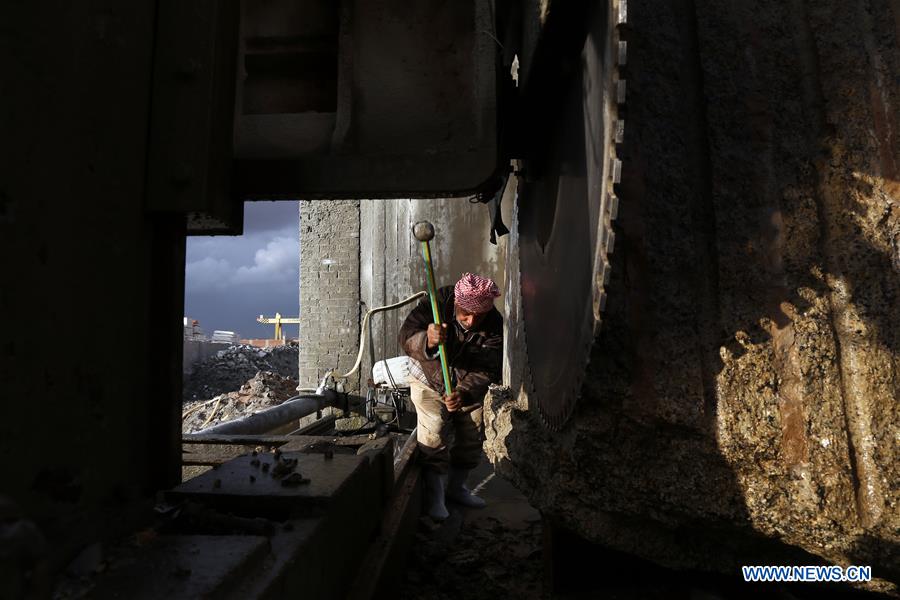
<box><xmin>299</xmin><ymin>200</ymin><xmax>360</xmax><ymax>390</ymax></box>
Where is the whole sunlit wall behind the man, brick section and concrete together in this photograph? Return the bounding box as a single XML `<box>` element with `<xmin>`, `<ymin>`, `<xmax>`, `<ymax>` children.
<box><xmin>299</xmin><ymin>197</ymin><xmax>512</xmax><ymax>388</ymax></box>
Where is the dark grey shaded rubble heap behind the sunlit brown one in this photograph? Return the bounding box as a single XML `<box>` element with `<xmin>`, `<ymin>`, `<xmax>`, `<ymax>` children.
<box><xmin>182</xmin><ymin>346</ymin><xmax>299</xmax><ymax>402</ymax></box>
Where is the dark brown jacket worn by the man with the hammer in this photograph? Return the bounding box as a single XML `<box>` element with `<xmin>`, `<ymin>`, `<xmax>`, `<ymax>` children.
<box><xmin>400</xmin><ymin>286</ymin><xmax>503</xmax><ymax>404</ymax></box>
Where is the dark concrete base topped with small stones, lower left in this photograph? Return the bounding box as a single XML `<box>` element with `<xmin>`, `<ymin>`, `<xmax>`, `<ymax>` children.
<box><xmin>82</xmin><ymin>436</ymin><xmax>393</xmax><ymax>600</ymax></box>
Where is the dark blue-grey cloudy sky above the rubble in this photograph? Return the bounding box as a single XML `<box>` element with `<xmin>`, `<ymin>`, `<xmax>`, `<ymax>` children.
<box><xmin>184</xmin><ymin>201</ymin><xmax>300</xmax><ymax>338</ymax></box>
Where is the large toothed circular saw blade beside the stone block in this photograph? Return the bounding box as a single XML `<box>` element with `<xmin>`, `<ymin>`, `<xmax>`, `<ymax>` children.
<box><xmin>519</xmin><ymin>3</ymin><xmax>623</xmax><ymax>429</ymax></box>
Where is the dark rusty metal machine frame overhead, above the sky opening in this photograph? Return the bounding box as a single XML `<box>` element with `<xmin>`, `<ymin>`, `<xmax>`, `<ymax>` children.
<box><xmin>147</xmin><ymin>0</ymin><xmax>504</xmax><ymax>235</ymax></box>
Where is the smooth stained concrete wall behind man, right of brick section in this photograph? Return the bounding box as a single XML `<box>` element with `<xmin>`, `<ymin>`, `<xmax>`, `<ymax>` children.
<box><xmin>359</xmin><ymin>198</ymin><xmax>512</xmax><ymax>381</ymax></box>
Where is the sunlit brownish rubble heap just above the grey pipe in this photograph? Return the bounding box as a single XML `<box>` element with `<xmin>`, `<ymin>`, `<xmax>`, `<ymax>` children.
<box><xmin>181</xmin><ymin>371</ymin><xmax>297</xmax><ymax>433</ymax></box>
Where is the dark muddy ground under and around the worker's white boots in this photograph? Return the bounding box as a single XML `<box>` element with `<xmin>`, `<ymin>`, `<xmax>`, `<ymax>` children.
<box><xmin>395</xmin><ymin>461</ymin><xmax>879</xmax><ymax>600</ymax></box>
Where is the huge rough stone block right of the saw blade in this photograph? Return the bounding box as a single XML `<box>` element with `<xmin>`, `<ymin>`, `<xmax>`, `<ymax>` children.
<box><xmin>486</xmin><ymin>0</ymin><xmax>900</xmax><ymax>587</ymax></box>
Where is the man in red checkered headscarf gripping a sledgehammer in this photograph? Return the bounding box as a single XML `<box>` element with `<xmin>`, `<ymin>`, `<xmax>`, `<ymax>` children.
<box><xmin>400</xmin><ymin>273</ymin><xmax>503</xmax><ymax>520</ymax></box>
